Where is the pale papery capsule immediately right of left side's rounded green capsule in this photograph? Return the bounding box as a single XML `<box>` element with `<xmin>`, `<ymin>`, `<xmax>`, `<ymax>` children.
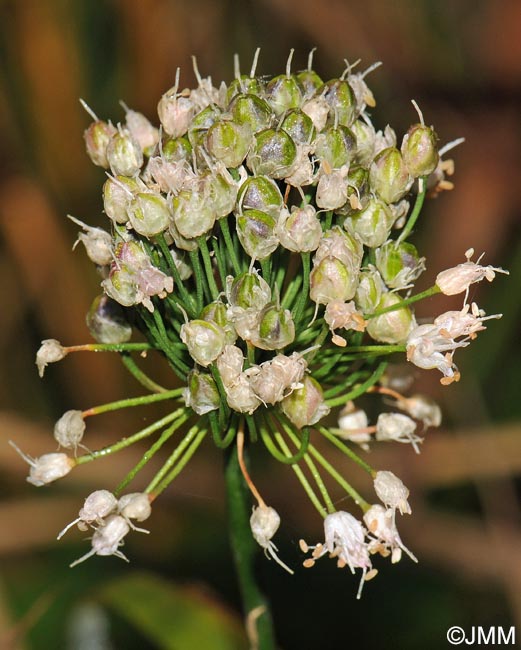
<box><xmin>170</xmin><ymin>189</ymin><xmax>216</xmax><ymax>239</ymax></box>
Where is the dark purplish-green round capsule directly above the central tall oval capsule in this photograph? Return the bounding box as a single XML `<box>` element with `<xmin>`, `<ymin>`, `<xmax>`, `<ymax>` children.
<box><xmin>246</xmin><ymin>129</ymin><xmax>297</xmax><ymax>178</ymax></box>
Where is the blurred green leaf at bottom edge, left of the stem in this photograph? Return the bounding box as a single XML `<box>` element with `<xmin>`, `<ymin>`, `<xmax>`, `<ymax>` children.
<box><xmin>97</xmin><ymin>573</ymin><xmax>248</xmax><ymax>650</ymax></box>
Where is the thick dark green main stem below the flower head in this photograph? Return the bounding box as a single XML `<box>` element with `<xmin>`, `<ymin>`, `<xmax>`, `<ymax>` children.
<box><xmin>225</xmin><ymin>446</ymin><xmax>276</xmax><ymax>650</ymax></box>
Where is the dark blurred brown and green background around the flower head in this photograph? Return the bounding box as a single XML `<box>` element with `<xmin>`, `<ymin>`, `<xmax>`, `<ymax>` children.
<box><xmin>0</xmin><ymin>0</ymin><xmax>521</xmax><ymax>650</ymax></box>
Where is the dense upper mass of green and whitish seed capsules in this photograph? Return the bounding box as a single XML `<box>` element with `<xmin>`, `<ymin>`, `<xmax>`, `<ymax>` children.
<box><xmin>76</xmin><ymin>51</ymin><xmax>443</xmax><ymax>427</ymax></box>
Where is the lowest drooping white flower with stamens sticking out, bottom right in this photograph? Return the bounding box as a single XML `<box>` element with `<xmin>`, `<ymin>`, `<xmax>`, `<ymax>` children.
<box><xmin>300</xmin><ymin>510</ymin><xmax>377</xmax><ymax>599</ymax></box>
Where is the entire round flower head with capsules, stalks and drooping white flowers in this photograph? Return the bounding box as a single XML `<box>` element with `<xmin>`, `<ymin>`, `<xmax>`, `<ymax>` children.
<box><xmin>12</xmin><ymin>51</ymin><xmax>507</xmax><ymax>598</ymax></box>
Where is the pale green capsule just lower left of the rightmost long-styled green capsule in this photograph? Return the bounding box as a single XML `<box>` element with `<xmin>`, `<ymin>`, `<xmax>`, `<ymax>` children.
<box><xmin>369</xmin><ymin>147</ymin><xmax>412</xmax><ymax>203</ymax></box>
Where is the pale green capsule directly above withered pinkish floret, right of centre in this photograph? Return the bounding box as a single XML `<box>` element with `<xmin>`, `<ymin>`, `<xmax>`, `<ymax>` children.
<box><xmin>309</xmin><ymin>257</ymin><xmax>358</xmax><ymax>305</ymax></box>
